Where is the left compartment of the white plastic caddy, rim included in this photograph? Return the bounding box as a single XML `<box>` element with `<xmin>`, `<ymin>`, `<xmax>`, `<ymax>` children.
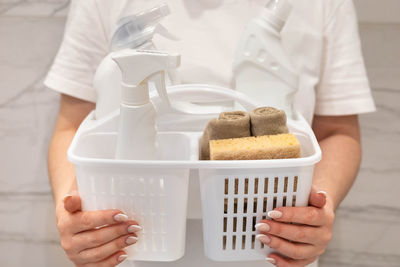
<box><xmin>70</xmin><ymin>131</ymin><xmax>191</xmax><ymax>261</ymax></box>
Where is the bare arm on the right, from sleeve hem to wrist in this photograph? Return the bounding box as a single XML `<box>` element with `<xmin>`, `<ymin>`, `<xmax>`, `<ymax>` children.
<box><xmin>312</xmin><ymin>115</ymin><xmax>361</xmax><ymax>209</ymax></box>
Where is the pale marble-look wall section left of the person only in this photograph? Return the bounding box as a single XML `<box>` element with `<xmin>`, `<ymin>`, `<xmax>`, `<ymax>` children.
<box><xmin>0</xmin><ymin>0</ymin><xmax>71</xmax><ymax>267</ymax></box>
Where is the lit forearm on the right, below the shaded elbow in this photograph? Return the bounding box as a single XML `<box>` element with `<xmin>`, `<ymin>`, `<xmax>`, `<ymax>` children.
<box><xmin>313</xmin><ymin>134</ymin><xmax>361</xmax><ymax>209</ymax></box>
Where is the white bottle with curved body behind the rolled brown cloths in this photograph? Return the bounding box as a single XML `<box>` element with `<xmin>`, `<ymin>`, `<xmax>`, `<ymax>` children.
<box><xmin>233</xmin><ymin>0</ymin><xmax>298</xmax><ymax>118</ymax></box>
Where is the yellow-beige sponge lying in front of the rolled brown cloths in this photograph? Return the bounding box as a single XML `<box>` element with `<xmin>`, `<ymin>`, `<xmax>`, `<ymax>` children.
<box><xmin>210</xmin><ymin>134</ymin><xmax>301</xmax><ymax>160</ymax></box>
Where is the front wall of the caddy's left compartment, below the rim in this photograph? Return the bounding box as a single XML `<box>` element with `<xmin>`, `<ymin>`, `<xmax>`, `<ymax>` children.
<box><xmin>78</xmin><ymin>168</ymin><xmax>189</xmax><ymax>260</ymax></box>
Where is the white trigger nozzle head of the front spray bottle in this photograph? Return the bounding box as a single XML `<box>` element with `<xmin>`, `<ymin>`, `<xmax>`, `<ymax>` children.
<box><xmin>111</xmin><ymin>49</ymin><xmax>180</xmax><ymax>105</ymax></box>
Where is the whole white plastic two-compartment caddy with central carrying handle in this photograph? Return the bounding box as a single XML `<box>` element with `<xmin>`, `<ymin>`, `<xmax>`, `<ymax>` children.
<box><xmin>68</xmin><ymin>85</ymin><xmax>321</xmax><ymax>261</ymax></box>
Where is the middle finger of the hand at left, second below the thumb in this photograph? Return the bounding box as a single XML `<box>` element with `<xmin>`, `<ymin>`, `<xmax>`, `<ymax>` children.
<box><xmin>73</xmin><ymin>221</ymin><xmax>142</xmax><ymax>252</ymax></box>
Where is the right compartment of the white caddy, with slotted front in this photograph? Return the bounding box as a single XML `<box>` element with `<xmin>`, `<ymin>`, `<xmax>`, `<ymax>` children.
<box><xmin>199</xmin><ymin>133</ymin><xmax>319</xmax><ymax>261</ymax></box>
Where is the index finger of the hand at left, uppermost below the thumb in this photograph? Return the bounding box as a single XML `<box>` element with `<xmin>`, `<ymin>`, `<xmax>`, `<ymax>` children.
<box><xmin>69</xmin><ymin>210</ymin><xmax>128</xmax><ymax>234</ymax></box>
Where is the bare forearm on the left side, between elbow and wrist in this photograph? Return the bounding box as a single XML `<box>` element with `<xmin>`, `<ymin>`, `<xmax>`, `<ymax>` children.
<box><xmin>48</xmin><ymin>130</ymin><xmax>77</xmax><ymax>205</ymax></box>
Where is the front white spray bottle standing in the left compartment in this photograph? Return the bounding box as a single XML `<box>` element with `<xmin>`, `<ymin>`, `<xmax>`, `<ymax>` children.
<box><xmin>111</xmin><ymin>49</ymin><xmax>180</xmax><ymax>160</ymax></box>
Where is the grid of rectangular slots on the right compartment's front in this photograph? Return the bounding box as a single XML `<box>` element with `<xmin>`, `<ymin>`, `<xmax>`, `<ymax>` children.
<box><xmin>217</xmin><ymin>175</ymin><xmax>299</xmax><ymax>255</ymax></box>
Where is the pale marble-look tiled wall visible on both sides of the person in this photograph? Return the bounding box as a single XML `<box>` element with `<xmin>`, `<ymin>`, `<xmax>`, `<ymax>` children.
<box><xmin>0</xmin><ymin>0</ymin><xmax>400</xmax><ymax>267</ymax></box>
